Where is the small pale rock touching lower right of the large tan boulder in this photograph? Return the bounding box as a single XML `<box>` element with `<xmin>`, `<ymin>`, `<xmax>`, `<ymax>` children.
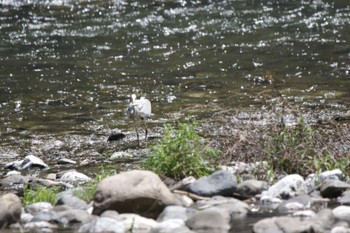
<box><xmin>157</xmin><ymin>206</ymin><xmax>197</xmax><ymax>222</ymax></box>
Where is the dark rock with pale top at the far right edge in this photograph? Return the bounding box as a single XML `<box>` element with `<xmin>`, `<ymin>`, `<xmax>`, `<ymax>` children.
<box><xmin>320</xmin><ymin>179</ymin><xmax>350</xmax><ymax>198</ymax></box>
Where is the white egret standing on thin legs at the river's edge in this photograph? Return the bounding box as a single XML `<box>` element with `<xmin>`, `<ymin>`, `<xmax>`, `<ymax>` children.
<box><xmin>126</xmin><ymin>94</ymin><xmax>152</xmax><ymax>146</ymax></box>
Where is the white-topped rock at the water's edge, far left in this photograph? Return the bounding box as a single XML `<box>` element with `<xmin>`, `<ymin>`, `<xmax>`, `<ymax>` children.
<box><xmin>5</xmin><ymin>154</ymin><xmax>49</xmax><ymax>170</ymax></box>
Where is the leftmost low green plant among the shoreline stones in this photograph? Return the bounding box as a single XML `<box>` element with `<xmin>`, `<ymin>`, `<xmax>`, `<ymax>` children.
<box><xmin>23</xmin><ymin>185</ymin><xmax>60</xmax><ymax>205</ymax></box>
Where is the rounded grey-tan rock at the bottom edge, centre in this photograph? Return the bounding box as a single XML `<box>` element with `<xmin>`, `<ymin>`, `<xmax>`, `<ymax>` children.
<box><xmin>186</xmin><ymin>209</ymin><xmax>230</xmax><ymax>233</ymax></box>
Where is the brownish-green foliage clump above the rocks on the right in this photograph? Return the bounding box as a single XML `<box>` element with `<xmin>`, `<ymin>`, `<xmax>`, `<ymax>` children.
<box><xmin>265</xmin><ymin>117</ymin><xmax>349</xmax><ymax>176</ymax></box>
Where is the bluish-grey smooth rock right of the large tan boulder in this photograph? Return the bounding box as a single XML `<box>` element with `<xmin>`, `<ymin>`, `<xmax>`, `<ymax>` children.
<box><xmin>185</xmin><ymin>170</ymin><xmax>237</xmax><ymax>197</ymax></box>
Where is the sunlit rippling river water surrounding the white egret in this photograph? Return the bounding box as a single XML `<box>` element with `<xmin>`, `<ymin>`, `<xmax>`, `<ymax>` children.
<box><xmin>0</xmin><ymin>0</ymin><xmax>350</xmax><ymax>231</ymax></box>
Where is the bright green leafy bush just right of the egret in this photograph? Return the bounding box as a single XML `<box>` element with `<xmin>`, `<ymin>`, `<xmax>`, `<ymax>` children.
<box><xmin>144</xmin><ymin>119</ymin><xmax>221</xmax><ymax>179</ymax></box>
